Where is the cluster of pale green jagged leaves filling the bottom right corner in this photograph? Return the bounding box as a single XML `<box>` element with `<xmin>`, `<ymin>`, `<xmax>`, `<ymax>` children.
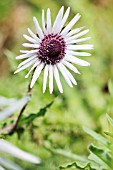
<box><xmin>51</xmin><ymin>115</ymin><xmax>113</xmax><ymax>170</ymax></box>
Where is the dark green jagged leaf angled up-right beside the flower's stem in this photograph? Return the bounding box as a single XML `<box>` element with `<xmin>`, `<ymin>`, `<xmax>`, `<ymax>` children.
<box><xmin>19</xmin><ymin>101</ymin><xmax>53</xmax><ymax>126</ymax></box>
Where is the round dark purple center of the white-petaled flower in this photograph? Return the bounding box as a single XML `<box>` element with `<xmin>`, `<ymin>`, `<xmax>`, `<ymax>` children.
<box><xmin>38</xmin><ymin>34</ymin><xmax>66</xmax><ymax>65</ymax></box>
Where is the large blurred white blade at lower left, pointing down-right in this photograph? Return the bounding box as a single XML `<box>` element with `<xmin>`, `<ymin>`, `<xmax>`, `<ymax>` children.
<box><xmin>0</xmin><ymin>139</ymin><xmax>41</xmax><ymax>164</ymax></box>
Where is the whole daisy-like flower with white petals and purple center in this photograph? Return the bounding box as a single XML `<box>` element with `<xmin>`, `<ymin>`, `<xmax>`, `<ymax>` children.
<box><xmin>15</xmin><ymin>6</ymin><xmax>93</xmax><ymax>93</ymax></box>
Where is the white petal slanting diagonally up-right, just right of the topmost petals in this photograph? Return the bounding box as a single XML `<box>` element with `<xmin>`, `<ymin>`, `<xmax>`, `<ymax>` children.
<box><xmin>61</xmin><ymin>13</ymin><xmax>80</xmax><ymax>36</ymax></box>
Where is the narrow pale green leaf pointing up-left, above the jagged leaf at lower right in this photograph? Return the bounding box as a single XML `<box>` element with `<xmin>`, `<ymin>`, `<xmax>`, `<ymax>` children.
<box><xmin>83</xmin><ymin>127</ymin><xmax>110</xmax><ymax>147</ymax></box>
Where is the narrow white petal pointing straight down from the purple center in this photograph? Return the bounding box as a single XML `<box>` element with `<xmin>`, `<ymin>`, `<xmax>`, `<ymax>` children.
<box><xmin>49</xmin><ymin>64</ymin><xmax>53</xmax><ymax>94</ymax></box>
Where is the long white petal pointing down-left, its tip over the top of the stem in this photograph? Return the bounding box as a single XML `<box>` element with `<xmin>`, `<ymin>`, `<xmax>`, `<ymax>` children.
<box><xmin>30</xmin><ymin>63</ymin><xmax>44</xmax><ymax>88</ymax></box>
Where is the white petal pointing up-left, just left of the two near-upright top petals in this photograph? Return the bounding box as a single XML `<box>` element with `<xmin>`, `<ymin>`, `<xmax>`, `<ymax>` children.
<box><xmin>33</xmin><ymin>17</ymin><xmax>44</xmax><ymax>39</ymax></box>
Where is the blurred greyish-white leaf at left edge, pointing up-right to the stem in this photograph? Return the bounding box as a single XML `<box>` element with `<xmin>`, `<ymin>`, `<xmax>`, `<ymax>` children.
<box><xmin>0</xmin><ymin>96</ymin><xmax>31</xmax><ymax>121</ymax></box>
